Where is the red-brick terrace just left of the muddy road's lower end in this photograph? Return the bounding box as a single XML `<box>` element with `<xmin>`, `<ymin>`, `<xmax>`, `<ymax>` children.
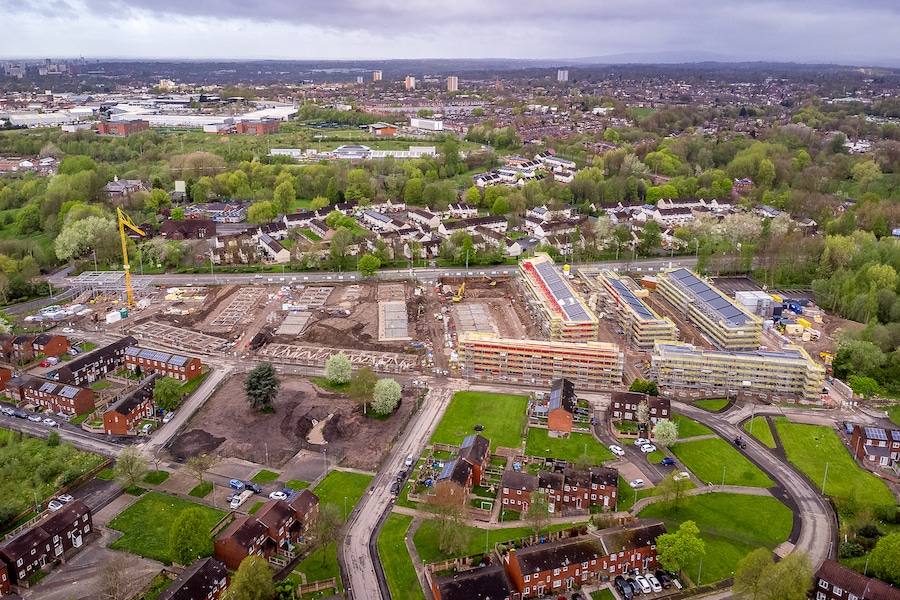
<box><xmin>214</xmin><ymin>490</ymin><xmax>319</xmax><ymax>571</ymax></box>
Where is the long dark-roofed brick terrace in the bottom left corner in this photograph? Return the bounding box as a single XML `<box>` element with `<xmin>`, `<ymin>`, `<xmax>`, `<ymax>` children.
<box><xmin>0</xmin><ymin>500</ymin><xmax>94</xmax><ymax>583</ymax></box>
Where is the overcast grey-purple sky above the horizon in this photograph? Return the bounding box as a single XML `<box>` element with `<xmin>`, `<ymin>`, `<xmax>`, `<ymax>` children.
<box><xmin>0</xmin><ymin>0</ymin><xmax>900</xmax><ymax>65</ymax></box>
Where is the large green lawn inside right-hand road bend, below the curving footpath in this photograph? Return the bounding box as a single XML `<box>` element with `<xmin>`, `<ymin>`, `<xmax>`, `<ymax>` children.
<box><xmin>639</xmin><ymin>494</ymin><xmax>793</xmax><ymax>583</ymax></box>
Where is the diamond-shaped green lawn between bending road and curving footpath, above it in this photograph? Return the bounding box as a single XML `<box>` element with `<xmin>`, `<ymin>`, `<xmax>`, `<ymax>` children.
<box><xmin>671</xmin><ymin>438</ymin><xmax>775</xmax><ymax>488</ymax></box>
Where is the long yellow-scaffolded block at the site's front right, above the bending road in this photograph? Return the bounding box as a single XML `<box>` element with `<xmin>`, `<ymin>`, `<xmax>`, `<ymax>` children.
<box><xmin>650</xmin><ymin>342</ymin><xmax>825</xmax><ymax>401</ymax></box>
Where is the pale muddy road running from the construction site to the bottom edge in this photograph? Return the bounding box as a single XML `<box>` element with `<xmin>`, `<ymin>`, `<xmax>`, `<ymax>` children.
<box><xmin>338</xmin><ymin>379</ymin><xmax>467</xmax><ymax>599</ymax></box>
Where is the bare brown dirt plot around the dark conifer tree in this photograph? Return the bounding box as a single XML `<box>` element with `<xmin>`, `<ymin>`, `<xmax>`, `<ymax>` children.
<box><xmin>170</xmin><ymin>376</ymin><xmax>417</xmax><ymax>470</ymax></box>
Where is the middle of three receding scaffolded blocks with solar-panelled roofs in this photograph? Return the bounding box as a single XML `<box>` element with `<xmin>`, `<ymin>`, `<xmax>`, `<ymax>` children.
<box><xmin>597</xmin><ymin>270</ymin><xmax>678</xmax><ymax>350</ymax></box>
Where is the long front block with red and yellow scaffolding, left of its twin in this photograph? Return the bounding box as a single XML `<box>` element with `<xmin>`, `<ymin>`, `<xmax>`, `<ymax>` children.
<box><xmin>459</xmin><ymin>331</ymin><xmax>624</xmax><ymax>390</ymax></box>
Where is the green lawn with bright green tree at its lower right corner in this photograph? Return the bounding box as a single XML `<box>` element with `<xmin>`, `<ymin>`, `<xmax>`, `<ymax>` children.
<box><xmin>109</xmin><ymin>492</ymin><xmax>225</xmax><ymax>564</ymax></box>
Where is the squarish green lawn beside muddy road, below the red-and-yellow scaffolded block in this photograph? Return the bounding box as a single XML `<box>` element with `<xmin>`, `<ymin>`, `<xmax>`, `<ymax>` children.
<box><xmin>431</xmin><ymin>392</ymin><xmax>528</xmax><ymax>452</ymax></box>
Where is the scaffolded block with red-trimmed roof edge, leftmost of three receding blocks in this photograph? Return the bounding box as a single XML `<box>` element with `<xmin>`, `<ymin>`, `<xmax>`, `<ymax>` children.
<box><xmin>519</xmin><ymin>254</ymin><xmax>600</xmax><ymax>342</ymax></box>
